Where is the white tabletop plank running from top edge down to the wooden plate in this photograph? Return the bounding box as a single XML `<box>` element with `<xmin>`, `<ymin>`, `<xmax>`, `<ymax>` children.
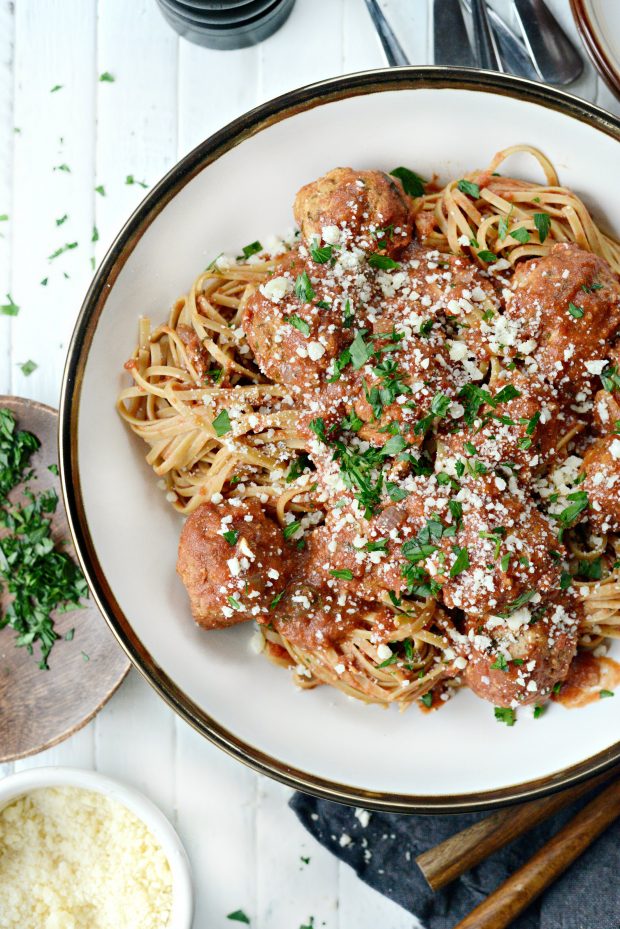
<box><xmin>12</xmin><ymin>0</ymin><xmax>96</xmax><ymax>405</ymax></box>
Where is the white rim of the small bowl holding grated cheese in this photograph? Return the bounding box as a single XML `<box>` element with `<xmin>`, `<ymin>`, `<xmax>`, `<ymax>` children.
<box><xmin>0</xmin><ymin>767</ymin><xmax>194</xmax><ymax>929</ymax></box>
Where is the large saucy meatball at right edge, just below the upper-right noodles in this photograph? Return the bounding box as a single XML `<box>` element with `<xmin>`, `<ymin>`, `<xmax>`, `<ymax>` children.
<box><xmin>505</xmin><ymin>244</ymin><xmax>620</xmax><ymax>403</ymax></box>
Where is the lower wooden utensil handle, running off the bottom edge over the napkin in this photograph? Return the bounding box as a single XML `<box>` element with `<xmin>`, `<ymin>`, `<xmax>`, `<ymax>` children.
<box><xmin>454</xmin><ymin>780</ymin><xmax>620</xmax><ymax>929</ymax></box>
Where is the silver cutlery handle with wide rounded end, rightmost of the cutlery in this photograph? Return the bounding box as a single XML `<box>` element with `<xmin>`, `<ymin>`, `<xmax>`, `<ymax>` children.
<box><xmin>513</xmin><ymin>0</ymin><xmax>583</xmax><ymax>84</ymax></box>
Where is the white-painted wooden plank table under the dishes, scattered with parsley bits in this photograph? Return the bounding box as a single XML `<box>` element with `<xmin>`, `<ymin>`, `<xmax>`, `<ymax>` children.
<box><xmin>0</xmin><ymin>0</ymin><xmax>620</xmax><ymax>929</ymax></box>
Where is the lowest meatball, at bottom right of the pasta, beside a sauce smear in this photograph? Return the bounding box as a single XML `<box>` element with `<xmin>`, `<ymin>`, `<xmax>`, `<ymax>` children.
<box><xmin>460</xmin><ymin>596</ymin><xmax>579</xmax><ymax>707</ymax></box>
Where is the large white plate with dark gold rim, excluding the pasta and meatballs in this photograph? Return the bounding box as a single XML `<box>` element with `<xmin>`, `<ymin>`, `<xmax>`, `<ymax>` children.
<box><xmin>61</xmin><ymin>68</ymin><xmax>620</xmax><ymax>811</ymax></box>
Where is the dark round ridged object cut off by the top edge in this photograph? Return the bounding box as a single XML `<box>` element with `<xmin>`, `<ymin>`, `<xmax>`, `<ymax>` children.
<box><xmin>157</xmin><ymin>0</ymin><xmax>295</xmax><ymax>49</ymax></box>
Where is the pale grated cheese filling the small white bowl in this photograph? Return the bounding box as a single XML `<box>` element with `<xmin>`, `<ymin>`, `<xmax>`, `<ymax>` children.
<box><xmin>0</xmin><ymin>787</ymin><xmax>172</xmax><ymax>929</ymax></box>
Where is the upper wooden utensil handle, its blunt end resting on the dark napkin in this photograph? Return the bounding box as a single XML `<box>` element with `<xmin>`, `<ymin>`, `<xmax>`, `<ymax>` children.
<box><xmin>416</xmin><ymin>773</ymin><xmax>610</xmax><ymax>891</ymax></box>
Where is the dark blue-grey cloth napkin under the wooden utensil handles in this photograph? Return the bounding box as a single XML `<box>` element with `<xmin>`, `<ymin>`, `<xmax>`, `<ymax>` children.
<box><xmin>290</xmin><ymin>793</ymin><xmax>620</xmax><ymax>929</ymax></box>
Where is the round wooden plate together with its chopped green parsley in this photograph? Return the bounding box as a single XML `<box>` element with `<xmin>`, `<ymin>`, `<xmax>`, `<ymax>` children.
<box><xmin>0</xmin><ymin>397</ymin><xmax>129</xmax><ymax>762</ymax></box>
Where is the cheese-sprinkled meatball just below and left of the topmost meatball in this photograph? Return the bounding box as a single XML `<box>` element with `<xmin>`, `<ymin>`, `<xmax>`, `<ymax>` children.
<box><xmin>242</xmin><ymin>251</ymin><xmax>353</xmax><ymax>389</ymax></box>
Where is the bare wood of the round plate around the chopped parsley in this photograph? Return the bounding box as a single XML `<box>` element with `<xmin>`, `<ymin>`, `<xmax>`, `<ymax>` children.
<box><xmin>0</xmin><ymin>397</ymin><xmax>130</xmax><ymax>762</ymax></box>
